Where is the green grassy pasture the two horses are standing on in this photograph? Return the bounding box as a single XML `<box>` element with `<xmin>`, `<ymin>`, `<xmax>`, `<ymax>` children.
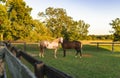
<box><xmin>12</xmin><ymin>41</ymin><xmax>120</xmax><ymax>78</ymax></box>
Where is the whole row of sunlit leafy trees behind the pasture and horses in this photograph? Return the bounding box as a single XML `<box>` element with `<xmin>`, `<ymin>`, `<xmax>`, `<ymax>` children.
<box><xmin>0</xmin><ymin>0</ymin><xmax>120</xmax><ymax>41</ymax></box>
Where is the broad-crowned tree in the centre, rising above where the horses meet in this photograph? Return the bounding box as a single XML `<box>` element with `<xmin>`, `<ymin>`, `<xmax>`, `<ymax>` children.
<box><xmin>38</xmin><ymin>7</ymin><xmax>72</xmax><ymax>37</ymax></box>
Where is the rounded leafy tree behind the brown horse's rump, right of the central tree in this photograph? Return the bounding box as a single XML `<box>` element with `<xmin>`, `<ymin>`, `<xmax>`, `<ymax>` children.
<box><xmin>64</xmin><ymin>20</ymin><xmax>90</xmax><ymax>40</ymax></box>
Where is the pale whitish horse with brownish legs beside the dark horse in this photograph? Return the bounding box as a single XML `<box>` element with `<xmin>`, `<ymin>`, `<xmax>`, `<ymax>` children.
<box><xmin>39</xmin><ymin>37</ymin><xmax>63</xmax><ymax>58</ymax></box>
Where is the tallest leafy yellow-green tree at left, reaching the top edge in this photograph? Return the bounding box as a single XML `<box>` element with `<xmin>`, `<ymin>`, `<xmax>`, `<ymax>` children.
<box><xmin>6</xmin><ymin>0</ymin><xmax>33</xmax><ymax>40</ymax></box>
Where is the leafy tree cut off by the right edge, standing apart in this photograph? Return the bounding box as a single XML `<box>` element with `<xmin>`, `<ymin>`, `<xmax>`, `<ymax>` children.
<box><xmin>110</xmin><ymin>18</ymin><xmax>120</xmax><ymax>41</ymax></box>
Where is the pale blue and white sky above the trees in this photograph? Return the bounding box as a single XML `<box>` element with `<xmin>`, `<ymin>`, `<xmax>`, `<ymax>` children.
<box><xmin>24</xmin><ymin>0</ymin><xmax>120</xmax><ymax>35</ymax></box>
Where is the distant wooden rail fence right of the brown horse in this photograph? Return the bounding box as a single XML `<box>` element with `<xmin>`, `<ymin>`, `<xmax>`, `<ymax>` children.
<box><xmin>91</xmin><ymin>42</ymin><xmax>120</xmax><ymax>52</ymax></box>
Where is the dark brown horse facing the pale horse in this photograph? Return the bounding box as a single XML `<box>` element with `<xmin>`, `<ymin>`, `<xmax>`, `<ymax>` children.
<box><xmin>61</xmin><ymin>40</ymin><xmax>82</xmax><ymax>57</ymax></box>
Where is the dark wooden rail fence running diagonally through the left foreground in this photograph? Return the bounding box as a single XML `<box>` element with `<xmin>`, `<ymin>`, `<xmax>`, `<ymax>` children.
<box><xmin>5</xmin><ymin>42</ymin><xmax>72</xmax><ymax>78</ymax></box>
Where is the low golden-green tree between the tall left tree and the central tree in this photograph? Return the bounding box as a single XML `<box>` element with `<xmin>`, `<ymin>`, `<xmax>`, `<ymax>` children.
<box><xmin>29</xmin><ymin>20</ymin><xmax>51</xmax><ymax>41</ymax></box>
